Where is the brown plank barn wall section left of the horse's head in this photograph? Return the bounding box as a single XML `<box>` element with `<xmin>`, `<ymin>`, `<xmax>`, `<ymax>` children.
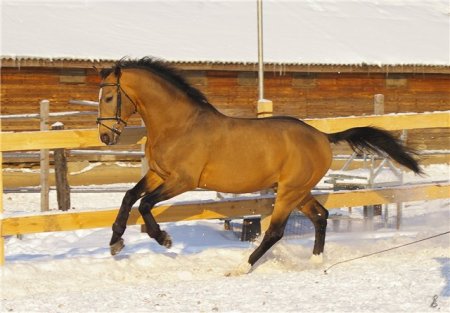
<box><xmin>1</xmin><ymin>67</ymin><xmax>99</xmax><ymax>131</ymax></box>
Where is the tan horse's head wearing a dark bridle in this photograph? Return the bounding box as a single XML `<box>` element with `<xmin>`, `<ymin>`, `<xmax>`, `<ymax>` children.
<box><xmin>97</xmin><ymin>66</ymin><xmax>137</xmax><ymax>145</ymax></box>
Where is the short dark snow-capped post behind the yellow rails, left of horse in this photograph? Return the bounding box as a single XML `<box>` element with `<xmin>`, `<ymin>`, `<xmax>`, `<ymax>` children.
<box><xmin>52</xmin><ymin>122</ymin><xmax>70</xmax><ymax>211</ymax></box>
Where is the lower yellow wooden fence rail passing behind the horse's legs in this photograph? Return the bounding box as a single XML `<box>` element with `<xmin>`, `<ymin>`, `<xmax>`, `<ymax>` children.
<box><xmin>1</xmin><ymin>182</ymin><xmax>450</xmax><ymax>237</ymax></box>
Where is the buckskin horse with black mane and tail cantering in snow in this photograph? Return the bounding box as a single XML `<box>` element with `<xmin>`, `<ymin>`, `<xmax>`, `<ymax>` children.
<box><xmin>97</xmin><ymin>57</ymin><xmax>422</xmax><ymax>272</ymax></box>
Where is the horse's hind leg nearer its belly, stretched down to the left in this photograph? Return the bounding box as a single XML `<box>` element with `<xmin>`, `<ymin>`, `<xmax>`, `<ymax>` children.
<box><xmin>248</xmin><ymin>187</ymin><xmax>310</xmax><ymax>266</ymax></box>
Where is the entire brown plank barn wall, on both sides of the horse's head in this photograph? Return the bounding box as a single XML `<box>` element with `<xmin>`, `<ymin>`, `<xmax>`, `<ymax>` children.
<box><xmin>1</xmin><ymin>67</ymin><xmax>450</xmax><ymax>149</ymax></box>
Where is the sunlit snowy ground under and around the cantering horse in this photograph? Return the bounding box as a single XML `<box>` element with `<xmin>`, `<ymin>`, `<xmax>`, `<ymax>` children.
<box><xmin>1</xmin><ymin>165</ymin><xmax>450</xmax><ymax>312</ymax></box>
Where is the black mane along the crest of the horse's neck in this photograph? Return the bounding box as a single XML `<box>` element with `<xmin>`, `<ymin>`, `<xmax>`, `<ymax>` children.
<box><xmin>100</xmin><ymin>57</ymin><xmax>215</xmax><ymax>110</ymax></box>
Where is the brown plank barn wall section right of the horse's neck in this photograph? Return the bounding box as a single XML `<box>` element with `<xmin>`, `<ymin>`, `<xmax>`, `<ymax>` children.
<box><xmin>199</xmin><ymin>71</ymin><xmax>450</xmax><ymax>118</ymax></box>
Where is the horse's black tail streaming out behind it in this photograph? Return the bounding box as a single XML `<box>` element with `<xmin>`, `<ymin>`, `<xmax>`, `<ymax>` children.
<box><xmin>328</xmin><ymin>127</ymin><xmax>423</xmax><ymax>174</ymax></box>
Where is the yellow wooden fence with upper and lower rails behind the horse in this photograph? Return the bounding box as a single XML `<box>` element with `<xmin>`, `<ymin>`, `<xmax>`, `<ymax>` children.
<box><xmin>0</xmin><ymin>111</ymin><xmax>450</xmax><ymax>264</ymax></box>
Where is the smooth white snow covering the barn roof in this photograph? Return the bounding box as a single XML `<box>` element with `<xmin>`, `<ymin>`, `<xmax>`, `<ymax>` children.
<box><xmin>0</xmin><ymin>0</ymin><xmax>450</xmax><ymax>66</ymax></box>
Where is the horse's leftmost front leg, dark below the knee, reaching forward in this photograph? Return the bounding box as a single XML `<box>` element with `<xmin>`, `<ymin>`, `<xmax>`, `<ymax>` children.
<box><xmin>109</xmin><ymin>171</ymin><xmax>164</xmax><ymax>255</ymax></box>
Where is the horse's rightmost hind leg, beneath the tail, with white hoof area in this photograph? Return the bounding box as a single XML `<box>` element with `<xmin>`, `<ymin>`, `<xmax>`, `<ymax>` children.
<box><xmin>299</xmin><ymin>194</ymin><xmax>328</xmax><ymax>262</ymax></box>
